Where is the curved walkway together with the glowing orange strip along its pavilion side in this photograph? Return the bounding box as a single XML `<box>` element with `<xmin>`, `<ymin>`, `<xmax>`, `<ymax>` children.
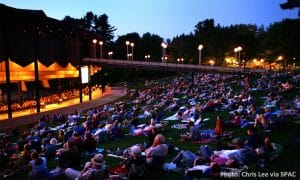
<box><xmin>0</xmin><ymin>88</ymin><xmax>126</xmax><ymax>130</ymax></box>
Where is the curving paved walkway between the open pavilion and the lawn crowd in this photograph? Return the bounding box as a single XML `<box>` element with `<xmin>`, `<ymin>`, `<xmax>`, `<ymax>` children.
<box><xmin>0</xmin><ymin>88</ymin><xmax>126</xmax><ymax>130</ymax></box>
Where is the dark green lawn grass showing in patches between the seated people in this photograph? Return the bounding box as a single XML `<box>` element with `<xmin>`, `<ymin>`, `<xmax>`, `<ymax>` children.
<box><xmin>1</xmin><ymin>74</ymin><xmax>300</xmax><ymax>180</ymax></box>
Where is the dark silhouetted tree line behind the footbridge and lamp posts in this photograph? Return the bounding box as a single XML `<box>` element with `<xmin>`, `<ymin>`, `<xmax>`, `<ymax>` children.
<box><xmin>63</xmin><ymin>12</ymin><xmax>300</xmax><ymax>65</ymax></box>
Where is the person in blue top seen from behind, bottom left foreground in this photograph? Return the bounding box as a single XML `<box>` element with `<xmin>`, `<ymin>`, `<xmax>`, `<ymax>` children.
<box><xmin>29</xmin><ymin>152</ymin><xmax>49</xmax><ymax>180</ymax></box>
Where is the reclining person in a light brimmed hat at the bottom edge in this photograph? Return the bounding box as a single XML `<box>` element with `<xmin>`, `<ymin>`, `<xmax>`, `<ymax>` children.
<box><xmin>65</xmin><ymin>154</ymin><xmax>107</xmax><ymax>180</ymax></box>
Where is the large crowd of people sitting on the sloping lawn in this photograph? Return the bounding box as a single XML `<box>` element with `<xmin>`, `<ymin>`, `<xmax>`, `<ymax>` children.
<box><xmin>0</xmin><ymin>71</ymin><xmax>300</xmax><ymax>179</ymax></box>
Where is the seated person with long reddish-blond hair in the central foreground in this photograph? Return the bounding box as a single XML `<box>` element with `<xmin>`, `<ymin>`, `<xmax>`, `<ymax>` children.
<box><xmin>145</xmin><ymin>134</ymin><xmax>168</xmax><ymax>166</ymax></box>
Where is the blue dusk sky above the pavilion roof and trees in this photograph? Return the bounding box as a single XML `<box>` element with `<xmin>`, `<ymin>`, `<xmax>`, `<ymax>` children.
<box><xmin>0</xmin><ymin>0</ymin><xmax>298</xmax><ymax>39</ymax></box>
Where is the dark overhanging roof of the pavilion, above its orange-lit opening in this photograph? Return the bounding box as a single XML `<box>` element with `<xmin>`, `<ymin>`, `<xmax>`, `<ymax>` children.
<box><xmin>0</xmin><ymin>4</ymin><xmax>101</xmax><ymax>66</ymax></box>
